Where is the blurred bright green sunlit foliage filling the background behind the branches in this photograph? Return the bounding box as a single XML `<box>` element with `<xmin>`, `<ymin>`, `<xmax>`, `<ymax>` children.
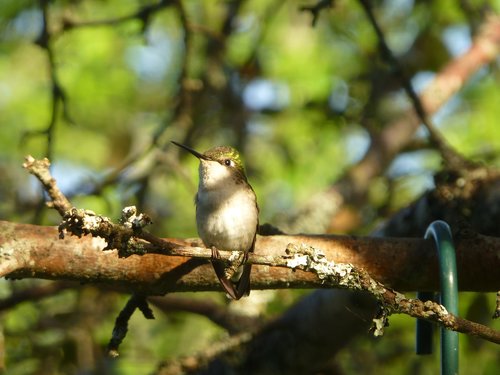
<box><xmin>0</xmin><ymin>0</ymin><xmax>500</xmax><ymax>374</ymax></box>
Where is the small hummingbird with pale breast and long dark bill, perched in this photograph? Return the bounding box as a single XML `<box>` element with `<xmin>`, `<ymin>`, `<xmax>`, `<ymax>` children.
<box><xmin>172</xmin><ymin>141</ymin><xmax>259</xmax><ymax>300</ymax></box>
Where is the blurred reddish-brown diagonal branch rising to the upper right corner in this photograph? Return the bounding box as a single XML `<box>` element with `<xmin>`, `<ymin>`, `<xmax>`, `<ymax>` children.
<box><xmin>283</xmin><ymin>15</ymin><xmax>500</xmax><ymax>232</ymax></box>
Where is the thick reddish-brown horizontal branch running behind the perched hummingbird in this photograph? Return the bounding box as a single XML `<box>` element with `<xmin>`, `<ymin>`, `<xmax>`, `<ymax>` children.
<box><xmin>0</xmin><ymin>217</ymin><xmax>500</xmax><ymax>295</ymax></box>
